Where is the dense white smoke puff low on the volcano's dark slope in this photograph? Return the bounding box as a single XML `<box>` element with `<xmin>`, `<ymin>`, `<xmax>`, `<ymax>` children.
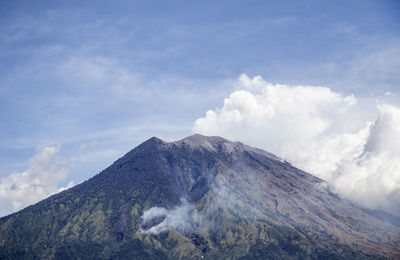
<box><xmin>141</xmin><ymin>198</ymin><xmax>193</xmax><ymax>234</ymax></box>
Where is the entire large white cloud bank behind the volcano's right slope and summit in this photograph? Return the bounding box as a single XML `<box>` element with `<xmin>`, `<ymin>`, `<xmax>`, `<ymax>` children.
<box><xmin>193</xmin><ymin>75</ymin><xmax>400</xmax><ymax>215</ymax></box>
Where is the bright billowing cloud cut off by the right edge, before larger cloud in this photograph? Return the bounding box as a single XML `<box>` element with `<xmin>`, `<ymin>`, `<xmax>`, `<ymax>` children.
<box><xmin>332</xmin><ymin>104</ymin><xmax>400</xmax><ymax>215</ymax></box>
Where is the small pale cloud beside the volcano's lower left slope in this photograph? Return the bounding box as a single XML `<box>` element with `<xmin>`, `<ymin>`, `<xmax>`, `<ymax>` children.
<box><xmin>0</xmin><ymin>146</ymin><xmax>73</xmax><ymax>213</ymax></box>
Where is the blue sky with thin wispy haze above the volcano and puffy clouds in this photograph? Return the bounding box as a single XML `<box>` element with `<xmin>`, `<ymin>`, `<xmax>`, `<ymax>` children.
<box><xmin>0</xmin><ymin>1</ymin><xmax>400</xmax><ymax>215</ymax></box>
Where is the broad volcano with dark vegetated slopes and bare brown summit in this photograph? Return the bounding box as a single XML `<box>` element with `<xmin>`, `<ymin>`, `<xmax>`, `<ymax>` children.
<box><xmin>0</xmin><ymin>135</ymin><xmax>400</xmax><ymax>259</ymax></box>
